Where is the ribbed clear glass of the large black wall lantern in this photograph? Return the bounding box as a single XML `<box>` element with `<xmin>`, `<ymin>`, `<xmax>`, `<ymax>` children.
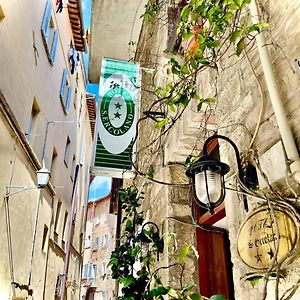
<box><xmin>195</xmin><ymin>169</ymin><xmax>223</xmax><ymax>205</ymax></box>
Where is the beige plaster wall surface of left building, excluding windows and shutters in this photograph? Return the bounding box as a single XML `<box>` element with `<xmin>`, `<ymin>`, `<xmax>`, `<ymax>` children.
<box><xmin>0</xmin><ymin>0</ymin><xmax>93</xmax><ymax>299</ymax></box>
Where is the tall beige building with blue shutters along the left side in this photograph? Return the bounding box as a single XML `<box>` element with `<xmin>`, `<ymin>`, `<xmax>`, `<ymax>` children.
<box><xmin>0</xmin><ymin>0</ymin><xmax>95</xmax><ymax>299</ymax></box>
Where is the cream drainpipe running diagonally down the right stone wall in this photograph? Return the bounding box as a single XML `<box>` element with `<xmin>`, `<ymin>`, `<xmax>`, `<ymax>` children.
<box><xmin>250</xmin><ymin>0</ymin><xmax>300</xmax><ymax>183</ymax></box>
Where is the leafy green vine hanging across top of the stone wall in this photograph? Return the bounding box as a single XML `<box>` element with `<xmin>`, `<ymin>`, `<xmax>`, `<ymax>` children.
<box><xmin>144</xmin><ymin>0</ymin><xmax>268</xmax><ymax>128</ymax></box>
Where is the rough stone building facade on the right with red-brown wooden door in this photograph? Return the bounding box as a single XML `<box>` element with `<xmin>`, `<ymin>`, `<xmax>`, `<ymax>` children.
<box><xmin>90</xmin><ymin>0</ymin><xmax>300</xmax><ymax>299</ymax></box>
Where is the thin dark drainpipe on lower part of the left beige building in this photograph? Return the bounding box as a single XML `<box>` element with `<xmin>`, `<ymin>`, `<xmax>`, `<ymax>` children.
<box><xmin>60</xmin><ymin>164</ymin><xmax>80</xmax><ymax>300</ymax></box>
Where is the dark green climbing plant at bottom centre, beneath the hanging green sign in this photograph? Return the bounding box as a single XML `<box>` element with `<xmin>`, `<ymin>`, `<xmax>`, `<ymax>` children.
<box><xmin>108</xmin><ymin>186</ymin><xmax>225</xmax><ymax>300</ymax></box>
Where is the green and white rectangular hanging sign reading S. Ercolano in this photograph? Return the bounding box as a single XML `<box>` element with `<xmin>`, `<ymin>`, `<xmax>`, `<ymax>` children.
<box><xmin>94</xmin><ymin>58</ymin><xmax>140</xmax><ymax>178</ymax></box>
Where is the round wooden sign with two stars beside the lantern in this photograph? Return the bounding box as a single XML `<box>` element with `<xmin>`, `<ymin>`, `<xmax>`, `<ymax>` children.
<box><xmin>237</xmin><ymin>205</ymin><xmax>299</xmax><ymax>269</ymax></box>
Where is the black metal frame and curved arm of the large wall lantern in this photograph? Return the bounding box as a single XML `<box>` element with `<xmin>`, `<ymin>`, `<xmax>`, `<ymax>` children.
<box><xmin>186</xmin><ymin>134</ymin><xmax>249</xmax><ymax>214</ymax></box>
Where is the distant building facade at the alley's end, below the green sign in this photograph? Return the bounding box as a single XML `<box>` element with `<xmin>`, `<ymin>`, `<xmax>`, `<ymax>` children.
<box><xmin>81</xmin><ymin>194</ymin><xmax>117</xmax><ymax>300</ymax></box>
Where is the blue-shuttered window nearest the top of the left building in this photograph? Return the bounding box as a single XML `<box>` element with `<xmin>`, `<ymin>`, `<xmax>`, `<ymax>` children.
<box><xmin>41</xmin><ymin>0</ymin><xmax>58</xmax><ymax>65</ymax></box>
